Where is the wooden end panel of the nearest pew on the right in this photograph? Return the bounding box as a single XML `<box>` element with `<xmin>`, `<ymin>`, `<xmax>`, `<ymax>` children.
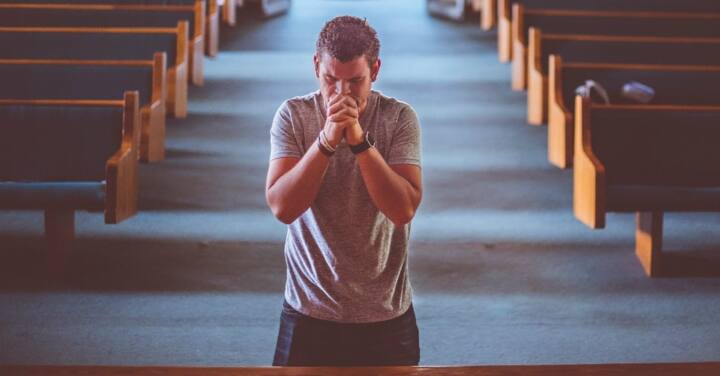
<box><xmin>573</xmin><ymin>96</ymin><xmax>607</xmax><ymax>229</ymax></box>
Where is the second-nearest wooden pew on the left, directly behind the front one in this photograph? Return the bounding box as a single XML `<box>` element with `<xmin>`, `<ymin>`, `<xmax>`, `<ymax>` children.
<box><xmin>0</xmin><ymin>53</ymin><xmax>166</xmax><ymax>162</ymax></box>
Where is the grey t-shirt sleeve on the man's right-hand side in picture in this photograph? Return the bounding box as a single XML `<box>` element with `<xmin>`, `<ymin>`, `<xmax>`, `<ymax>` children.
<box><xmin>388</xmin><ymin>105</ymin><xmax>420</xmax><ymax>166</ymax></box>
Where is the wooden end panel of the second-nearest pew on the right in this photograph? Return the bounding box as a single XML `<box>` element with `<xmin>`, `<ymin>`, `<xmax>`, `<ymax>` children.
<box><xmin>548</xmin><ymin>54</ymin><xmax>574</xmax><ymax>168</ymax></box>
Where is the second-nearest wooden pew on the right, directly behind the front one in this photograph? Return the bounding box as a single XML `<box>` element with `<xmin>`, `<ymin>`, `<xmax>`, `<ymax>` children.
<box><xmin>548</xmin><ymin>55</ymin><xmax>720</xmax><ymax>168</ymax></box>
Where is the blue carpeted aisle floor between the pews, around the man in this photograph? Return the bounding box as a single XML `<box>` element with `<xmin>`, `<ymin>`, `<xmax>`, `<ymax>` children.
<box><xmin>0</xmin><ymin>0</ymin><xmax>720</xmax><ymax>365</ymax></box>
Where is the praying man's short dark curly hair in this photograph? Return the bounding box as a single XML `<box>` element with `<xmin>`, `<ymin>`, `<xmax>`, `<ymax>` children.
<box><xmin>316</xmin><ymin>16</ymin><xmax>380</xmax><ymax>67</ymax></box>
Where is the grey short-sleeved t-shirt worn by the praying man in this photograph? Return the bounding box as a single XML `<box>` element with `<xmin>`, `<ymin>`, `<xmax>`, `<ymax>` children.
<box><xmin>270</xmin><ymin>91</ymin><xmax>420</xmax><ymax>323</ymax></box>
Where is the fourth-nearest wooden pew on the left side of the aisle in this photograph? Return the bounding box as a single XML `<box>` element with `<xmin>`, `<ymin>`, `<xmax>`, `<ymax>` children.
<box><xmin>0</xmin><ymin>0</ymin><xmax>205</xmax><ymax>86</ymax></box>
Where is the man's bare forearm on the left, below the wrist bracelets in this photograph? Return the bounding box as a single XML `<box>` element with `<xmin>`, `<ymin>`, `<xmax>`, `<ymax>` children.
<box><xmin>268</xmin><ymin>140</ymin><xmax>329</xmax><ymax>224</ymax></box>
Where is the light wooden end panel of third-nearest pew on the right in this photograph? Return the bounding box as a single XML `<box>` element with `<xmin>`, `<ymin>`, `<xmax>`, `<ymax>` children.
<box><xmin>526</xmin><ymin>27</ymin><xmax>548</xmax><ymax>125</ymax></box>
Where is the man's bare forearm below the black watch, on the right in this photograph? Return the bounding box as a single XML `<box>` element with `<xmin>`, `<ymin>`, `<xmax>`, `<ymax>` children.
<box><xmin>357</xmin><ymin>148</ymin><xmax>421</xmax><ymax>225</ymax></box>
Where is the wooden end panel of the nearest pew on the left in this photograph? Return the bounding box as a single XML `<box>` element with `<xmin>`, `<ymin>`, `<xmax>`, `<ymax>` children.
<box><xmin>105</xmin><ymin>91</ymin><xmax>140</xmax><ymax>223</ymax></box>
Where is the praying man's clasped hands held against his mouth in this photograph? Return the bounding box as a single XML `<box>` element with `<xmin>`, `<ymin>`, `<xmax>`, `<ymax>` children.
<box><xmin>322</xmin><ymin>94</ymin><xmax>363</xmax><ymax>147</ymax></box>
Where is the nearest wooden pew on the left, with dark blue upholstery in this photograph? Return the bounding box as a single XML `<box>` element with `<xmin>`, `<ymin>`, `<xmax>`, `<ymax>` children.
<box><xmin>0</xmin><ymin>92</ymin><xmax>140</xmax><ymax>272</ymax></box>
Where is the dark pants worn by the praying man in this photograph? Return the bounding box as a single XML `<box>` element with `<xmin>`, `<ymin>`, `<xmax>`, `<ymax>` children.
<box><xmin>273</xmin><ymin>302</ymin><xmax>420</xmax><ymax>366</ymax></box>
